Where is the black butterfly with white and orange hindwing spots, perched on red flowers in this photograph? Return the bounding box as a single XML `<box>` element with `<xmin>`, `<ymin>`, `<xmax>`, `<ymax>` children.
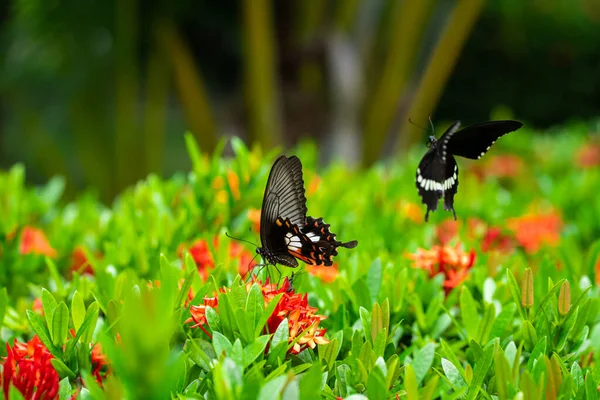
<box><xmin>256</xmin><ymin>156</ymin><xmax>358</xmax><ymax>267</ymax></box>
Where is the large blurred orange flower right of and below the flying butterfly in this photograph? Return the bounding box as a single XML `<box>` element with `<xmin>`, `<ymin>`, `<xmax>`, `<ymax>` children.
<box><xmin>507</xmin><ymin>213</ymin><xmax>562</xmax><ymax>254</ymax></box>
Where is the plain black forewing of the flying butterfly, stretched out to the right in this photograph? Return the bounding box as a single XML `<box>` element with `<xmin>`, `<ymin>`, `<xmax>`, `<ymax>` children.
<box><xmin>438</xmin><ymin>120</ymin><xmax>523</xmax><ymax>160</ymax></box>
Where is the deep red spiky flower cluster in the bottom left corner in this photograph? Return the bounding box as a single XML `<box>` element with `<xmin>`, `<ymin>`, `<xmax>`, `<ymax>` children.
<box><xmin>2</xmin><ymin>335</ymin><xmax>59</xmax><ymax>400</ymax></box>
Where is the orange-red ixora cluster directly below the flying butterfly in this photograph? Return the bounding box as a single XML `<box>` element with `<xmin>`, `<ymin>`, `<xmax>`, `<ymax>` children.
<box><xmin>407</xmin><ymin>243</ymin><xmax>475</xmax><ymax>294</ymax></box>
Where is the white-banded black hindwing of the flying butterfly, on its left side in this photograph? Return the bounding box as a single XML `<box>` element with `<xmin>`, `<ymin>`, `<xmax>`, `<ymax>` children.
<box><xmin>415</xmin><ymin>148</ymin><xmax>446</xmax><ymax>221</ymax></box>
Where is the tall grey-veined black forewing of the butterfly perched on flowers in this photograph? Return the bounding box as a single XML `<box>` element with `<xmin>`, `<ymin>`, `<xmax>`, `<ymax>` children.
<box><xmin>260</xmin><ymin>156</ymin><xmax>306</xmax><ymax>252</ymax></box>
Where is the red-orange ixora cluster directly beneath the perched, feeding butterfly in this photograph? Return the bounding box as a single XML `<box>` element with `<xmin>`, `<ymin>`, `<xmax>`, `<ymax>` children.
<box><xmin>186</xmin><ymin>277</ymin><xmax>329</xmax><ymax>354</ymax></box>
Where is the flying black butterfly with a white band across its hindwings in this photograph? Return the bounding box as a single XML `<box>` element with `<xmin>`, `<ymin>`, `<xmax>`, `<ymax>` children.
<box><xmin>416</xmin><ymin>120</ymin><xmax>523</xmax><ymax>221</ymax></box>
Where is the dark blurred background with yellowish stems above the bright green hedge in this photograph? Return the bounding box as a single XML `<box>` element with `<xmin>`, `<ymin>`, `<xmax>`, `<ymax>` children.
<box><xmin>0</xmin><ymin>0</ymin><xmax>600</xmax><ymax>201</ymax></box>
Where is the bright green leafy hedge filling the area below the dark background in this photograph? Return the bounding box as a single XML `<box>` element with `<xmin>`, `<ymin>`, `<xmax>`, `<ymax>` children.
<box><xmin>0</xmin><ymin>133</ymin><xmax>600</xmax><ymax>400</ymax></box>
